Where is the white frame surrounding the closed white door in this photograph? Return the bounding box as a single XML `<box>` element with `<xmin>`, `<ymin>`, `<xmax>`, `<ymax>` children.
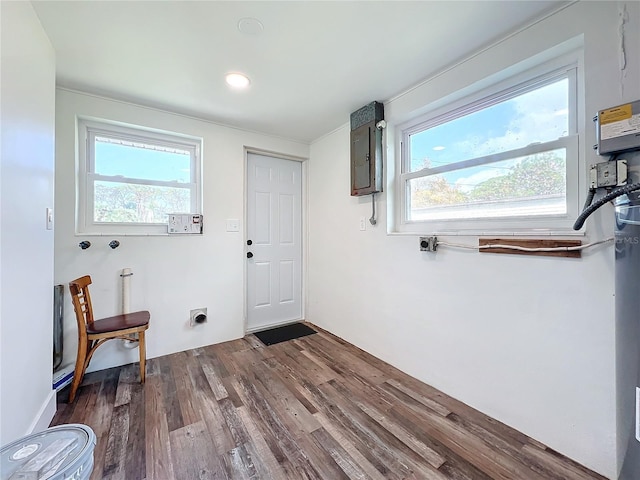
<box><xmin>242</xmin><ymin>145</ymin><xmax>309</xmax><ymax>335</ymax></box>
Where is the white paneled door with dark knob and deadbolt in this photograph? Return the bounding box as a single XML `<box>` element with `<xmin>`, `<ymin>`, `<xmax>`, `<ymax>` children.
<box><xmin>246</xmin><ymin>153</ymin><xmax>302</xmax><ymax>331</ymax></box>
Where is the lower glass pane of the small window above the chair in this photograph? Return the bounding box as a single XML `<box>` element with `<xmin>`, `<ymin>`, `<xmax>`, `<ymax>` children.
<box><xmin>93</xmin><ymin>181</ymin><xmax>191</xmax><ymax>223</ymax></box>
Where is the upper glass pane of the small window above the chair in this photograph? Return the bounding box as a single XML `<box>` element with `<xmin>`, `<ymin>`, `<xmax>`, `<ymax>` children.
<box><xmin>95</xmin><ymin>136</ymin><xmax>191</xmax><ymax>183</ymax></box>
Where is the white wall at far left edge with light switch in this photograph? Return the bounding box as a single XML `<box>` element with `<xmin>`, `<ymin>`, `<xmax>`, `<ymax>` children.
<box><xmin>0</xmin><ymin>2</ymin><xmax>55</xmax><ymax>445</ymax></box>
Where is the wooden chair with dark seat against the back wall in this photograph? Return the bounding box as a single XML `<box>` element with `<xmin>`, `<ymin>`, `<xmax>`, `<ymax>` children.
<box><xmin>69</xmin><ymin>275</ymin><xmax>151</xmax><ymax>403</ymax></box>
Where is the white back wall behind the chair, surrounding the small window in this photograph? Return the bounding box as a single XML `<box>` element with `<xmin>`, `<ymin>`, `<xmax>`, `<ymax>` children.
<box><xmin>55</xmin><ymin>89</ymin><xmax>309</xmax><ymax>371</ymax></box>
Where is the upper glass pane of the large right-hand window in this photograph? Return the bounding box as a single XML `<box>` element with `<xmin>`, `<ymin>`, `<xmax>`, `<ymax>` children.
<box><xmin>408</xmin><ymin>78</ymin><xmax>573</xmax><ymax>172</ymax></box>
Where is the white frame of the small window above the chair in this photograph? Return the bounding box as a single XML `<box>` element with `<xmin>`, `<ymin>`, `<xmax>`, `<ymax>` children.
<box><xmin>76</xmin><ymin>118</ymin><xmax>202</xmax><ymax>235</ymax></box>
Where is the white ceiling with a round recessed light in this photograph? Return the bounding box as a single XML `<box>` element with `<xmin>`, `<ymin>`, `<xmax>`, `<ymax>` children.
<box><xmin>32</xmin><ymin>0</ymin><xmax>567</xmax><ymax>142</ymax></box>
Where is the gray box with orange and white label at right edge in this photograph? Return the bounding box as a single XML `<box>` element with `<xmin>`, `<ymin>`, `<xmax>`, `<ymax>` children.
<box><xmin>594</xmin><ymin>100</ymin><xmax>640</xmax><ymax>155</ymax></box>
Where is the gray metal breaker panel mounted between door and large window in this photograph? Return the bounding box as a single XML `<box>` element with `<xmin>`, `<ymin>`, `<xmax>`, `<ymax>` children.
<box><xmin>351</xmin><ymin>102</ymin><xmax>384</xmax><ymax>196</ymax></box>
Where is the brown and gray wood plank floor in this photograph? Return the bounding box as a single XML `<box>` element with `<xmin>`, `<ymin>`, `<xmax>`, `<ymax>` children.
<box><xmin>52</xmin><ymin>324</ymin><xmax>604</xmax><ymax>480</ymax></box>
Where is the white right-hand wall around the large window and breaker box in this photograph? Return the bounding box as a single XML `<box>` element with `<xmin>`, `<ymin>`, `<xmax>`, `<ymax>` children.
<box><xmin>307</xmin><ymin>2</ymin><xmax>640</xmax><ymax>478</ymax></box>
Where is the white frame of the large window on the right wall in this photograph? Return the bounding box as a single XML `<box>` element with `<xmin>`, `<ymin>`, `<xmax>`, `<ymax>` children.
<box><xmin>393</xmin><ymin>51</ymin><xmax>584</xmax><ymax>236</ymax></box>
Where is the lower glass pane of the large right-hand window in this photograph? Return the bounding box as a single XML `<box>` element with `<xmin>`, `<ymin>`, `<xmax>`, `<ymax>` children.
<box><xmin>407</xmin><ymin>148</ymin><xmax>567</xmax><ymax>221</ymax></box>
